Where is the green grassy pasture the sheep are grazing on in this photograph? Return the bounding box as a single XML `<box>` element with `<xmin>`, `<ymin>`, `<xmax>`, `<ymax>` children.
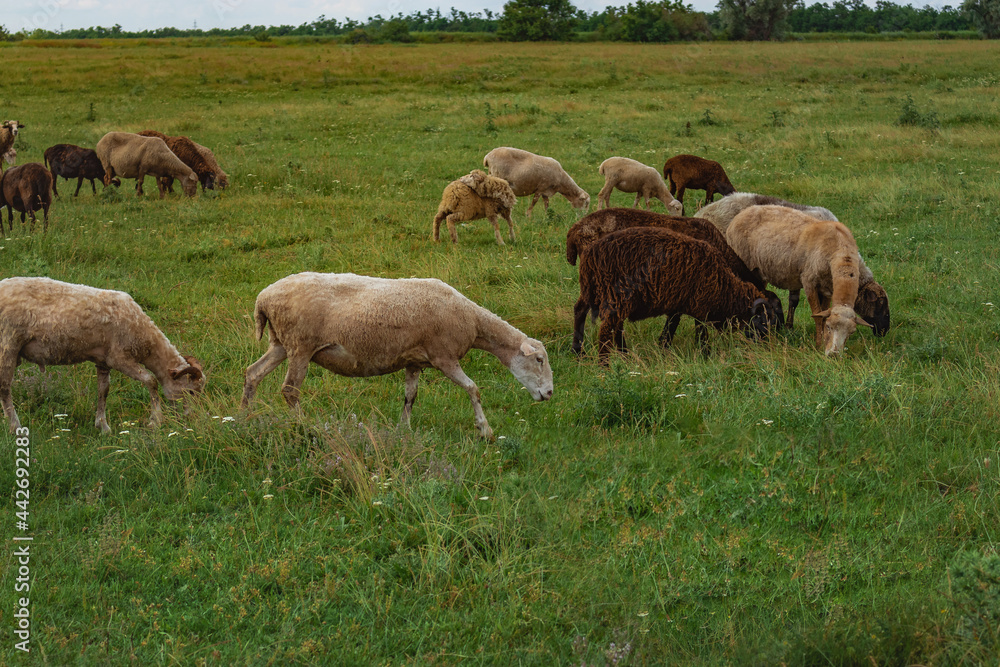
<box><xmin>0</xmin><ymin>40</ymin><xmax>1000</xmax><ymax>665</ymax></box>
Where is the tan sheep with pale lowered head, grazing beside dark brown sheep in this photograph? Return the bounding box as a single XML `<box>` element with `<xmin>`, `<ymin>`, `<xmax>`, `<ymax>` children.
<box><xmin>726</xmin><ymin>206</ymin><xmax>871</xmax><ymax>356</ymax></box>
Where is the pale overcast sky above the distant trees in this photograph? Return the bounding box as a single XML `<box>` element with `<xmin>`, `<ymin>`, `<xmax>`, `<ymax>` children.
<box><xmin>9</xmin><ymin>0</ymin><xmax>936</xmax><ymax>32</ymax></box>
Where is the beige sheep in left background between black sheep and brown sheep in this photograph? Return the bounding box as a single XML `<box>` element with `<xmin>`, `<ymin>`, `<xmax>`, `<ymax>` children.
<box><xmin>95</xmin><ymin>132</ymin><xmax>198</xmax><ymax>199</ymax></box>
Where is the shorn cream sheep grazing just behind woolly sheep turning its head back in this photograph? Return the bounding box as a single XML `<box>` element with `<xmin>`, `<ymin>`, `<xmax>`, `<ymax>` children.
<box><xmin>483</xmin><ymin>146</ymin><xmax>590</xmax><ymax>216</ymax></box>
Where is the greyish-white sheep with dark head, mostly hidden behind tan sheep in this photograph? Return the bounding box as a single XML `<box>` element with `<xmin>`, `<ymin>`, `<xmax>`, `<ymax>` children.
<box><xmin>695</xmin><ymin>192</ymin><xmax>889</xmax><ymax>336</ymax></box>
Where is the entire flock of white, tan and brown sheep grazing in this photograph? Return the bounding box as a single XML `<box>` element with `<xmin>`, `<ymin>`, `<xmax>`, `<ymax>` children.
<box><xmin>0</xmin><ymin>134</ymin><xmax>889</xmax><ymax>438</ymax></box>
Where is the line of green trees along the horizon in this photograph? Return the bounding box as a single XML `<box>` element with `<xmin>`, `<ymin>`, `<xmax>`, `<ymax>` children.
<box><xmin>0</xmin><ymin>0</ymin><xmax>1000</xmax><ymax>43</ymax></box>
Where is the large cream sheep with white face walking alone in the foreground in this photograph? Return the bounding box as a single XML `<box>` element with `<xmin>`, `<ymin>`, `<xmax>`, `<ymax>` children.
<box><xmin>243</xmin><ymin>273</ymin><xmax>552</xmax><ymax>439</ymax></box>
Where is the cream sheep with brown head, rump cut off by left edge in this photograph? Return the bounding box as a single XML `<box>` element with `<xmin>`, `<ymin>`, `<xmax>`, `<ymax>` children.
<box><xmin>0</xmin><ymin>278</ymin><xmax>205</xmax><ymax>433</ymax></box>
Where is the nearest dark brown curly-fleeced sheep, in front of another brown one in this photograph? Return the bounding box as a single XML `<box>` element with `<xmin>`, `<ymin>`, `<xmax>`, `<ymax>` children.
<box><xmin>573</xmin><ymin>227</ymin><xmax>781</xmax><ymax>363</ymax></box>
